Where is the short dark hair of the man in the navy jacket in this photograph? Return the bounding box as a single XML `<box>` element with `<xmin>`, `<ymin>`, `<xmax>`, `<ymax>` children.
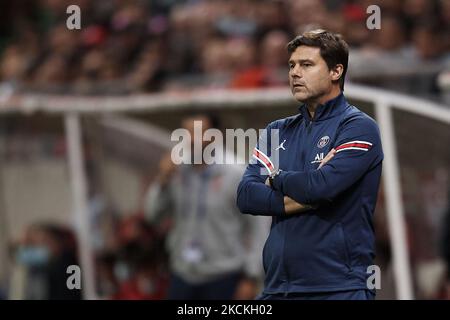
<box><xmin>287</xmin><ymin>29</ymin><xmax>348</xmax><ymax>91</ymax></box>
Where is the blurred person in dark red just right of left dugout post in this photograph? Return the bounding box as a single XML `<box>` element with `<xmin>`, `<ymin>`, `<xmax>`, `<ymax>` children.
<box><xmin>96</xmin><ymin>215</ymin><xmax>168</xmax><ymax>300</ymax></box>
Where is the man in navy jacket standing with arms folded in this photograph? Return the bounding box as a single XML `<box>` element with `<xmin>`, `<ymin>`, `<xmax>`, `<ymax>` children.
<box><xmin>237</xmin><ymin>30</ymin><xmax>383</xmax><ymax>299</ymax></box>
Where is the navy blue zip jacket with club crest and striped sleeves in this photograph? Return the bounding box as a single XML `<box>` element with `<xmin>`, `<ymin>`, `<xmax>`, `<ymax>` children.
<box><xmin>237</xmin><ymin>94</ymin><xmax>383</xmax><ymax>294</ymax></box>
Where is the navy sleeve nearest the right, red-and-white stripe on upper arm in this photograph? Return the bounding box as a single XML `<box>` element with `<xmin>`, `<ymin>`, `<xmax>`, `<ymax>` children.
<box><xmin>273</xmin><ymin>116</ymin><xmax>383</xmax><ymax>204</ymax></box>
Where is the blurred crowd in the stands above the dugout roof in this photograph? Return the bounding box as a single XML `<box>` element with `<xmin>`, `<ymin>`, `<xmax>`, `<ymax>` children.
<box><xmin>0</xmin><ymin>0</ymin><xmax>450</xmax><ymax>100</ymax></box>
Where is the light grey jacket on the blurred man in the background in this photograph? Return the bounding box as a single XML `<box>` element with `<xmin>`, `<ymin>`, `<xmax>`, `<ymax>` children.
<box><xmin>145</xmin><ymin>165</ymin><xmax>270</xmax><ymax>283</ymax></box>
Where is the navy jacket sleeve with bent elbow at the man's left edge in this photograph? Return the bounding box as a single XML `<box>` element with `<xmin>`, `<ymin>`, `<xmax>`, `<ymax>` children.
<box><xmin>237</xmin><ymin>123</ymin><xmax>284</xmax><ymax>216</ymax></box>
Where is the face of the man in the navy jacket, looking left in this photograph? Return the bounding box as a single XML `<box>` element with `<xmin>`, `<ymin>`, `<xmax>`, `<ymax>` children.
<box><xmin>289</xmin><ymin>46</ymin><xmax>332</xmax><ymax>102</ymax></box>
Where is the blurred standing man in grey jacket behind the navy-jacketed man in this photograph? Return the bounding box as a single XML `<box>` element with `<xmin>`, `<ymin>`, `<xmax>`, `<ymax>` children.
<box><xmin>146</xmin><ymin>115</ymin><xmax>268</xmax><ymax>299</ymax></box>
